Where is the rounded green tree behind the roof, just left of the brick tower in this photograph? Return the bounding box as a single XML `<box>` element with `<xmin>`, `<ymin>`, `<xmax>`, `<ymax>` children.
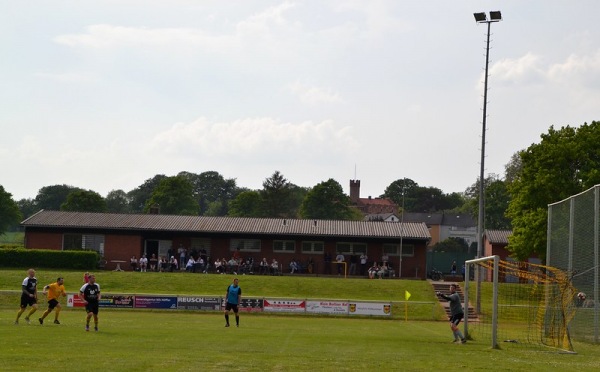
<box><xmin>300</xmin><ymin>179</ymin><xmax>357</xmax><ymax>220</ymax></box>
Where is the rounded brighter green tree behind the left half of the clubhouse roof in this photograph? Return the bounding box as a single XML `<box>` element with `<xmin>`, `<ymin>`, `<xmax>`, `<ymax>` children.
<box><xmin>144</xmin><ymin>176</ymin><xmax>198</xmax><ymax>216</ymax></box>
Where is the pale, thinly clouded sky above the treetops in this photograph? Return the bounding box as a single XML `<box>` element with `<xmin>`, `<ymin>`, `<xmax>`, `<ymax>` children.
<box><xmin>0</xmin><ymin>0</ymin><xmax>600</xmax><ymax>200</ymax></box>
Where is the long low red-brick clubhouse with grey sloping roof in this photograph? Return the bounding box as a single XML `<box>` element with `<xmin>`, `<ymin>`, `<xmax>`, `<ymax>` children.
<box><xmin>22</xmin><ymin>210</ymin><xmax>431</xmax><ymax>279</ymax></box>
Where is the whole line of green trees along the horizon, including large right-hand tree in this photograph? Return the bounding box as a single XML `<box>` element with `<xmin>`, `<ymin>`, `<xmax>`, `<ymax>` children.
<box><xmin>0</xmin><ymin>121</ymin><xmax>600</xmax><ymax>259</ymax></box>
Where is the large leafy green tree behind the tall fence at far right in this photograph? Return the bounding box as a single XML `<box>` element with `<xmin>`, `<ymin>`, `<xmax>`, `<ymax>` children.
<box><xmin>507</xmin><ymin>121</ymin><xmax>600</xmax><ymax>259</ymax></box>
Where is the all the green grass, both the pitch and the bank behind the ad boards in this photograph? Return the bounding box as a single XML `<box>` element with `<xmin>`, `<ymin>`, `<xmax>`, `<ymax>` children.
<box><xmin>0</xmin><ymin>270</ymin><xmax>600</xmax><ymax>371</ymax></box>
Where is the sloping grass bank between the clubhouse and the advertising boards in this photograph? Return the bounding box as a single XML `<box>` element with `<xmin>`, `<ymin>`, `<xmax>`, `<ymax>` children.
<box><xmin>0</xmin><ymin>270</ymin><xmax>445</xmax><ymax>320</ymax></box>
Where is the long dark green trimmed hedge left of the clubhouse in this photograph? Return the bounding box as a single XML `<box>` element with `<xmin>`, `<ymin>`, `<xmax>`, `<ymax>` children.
<box><xmin>0</xmin><ymin>248</ymin><xmax>100</xmax><ymax>270</ymax></box>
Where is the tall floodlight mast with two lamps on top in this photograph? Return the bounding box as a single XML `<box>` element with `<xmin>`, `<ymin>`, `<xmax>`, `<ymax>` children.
<box><xmin>473</xmin><ymin>10</ymin><xmax>502</xmax><ymax>313</ymax></box>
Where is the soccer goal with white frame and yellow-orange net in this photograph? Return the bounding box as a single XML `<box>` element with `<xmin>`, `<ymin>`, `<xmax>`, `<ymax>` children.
<box><xmin>464</xmin><ymin>256</ymin><xmax>577</xmax><ymax>352</ymax></box>
